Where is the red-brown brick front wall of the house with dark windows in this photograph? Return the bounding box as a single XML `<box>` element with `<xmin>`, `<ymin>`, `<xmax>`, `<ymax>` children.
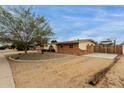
<box><xmin>57</xmin><ymin>43</ymin><xmax>88</xmax><ymax>55</ymax></box>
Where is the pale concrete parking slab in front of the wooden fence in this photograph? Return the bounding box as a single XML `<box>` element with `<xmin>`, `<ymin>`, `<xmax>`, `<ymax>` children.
<box><xmin>84</xmin><ymin>53</ymin><xmax>118</xmax><ymax>59</ymax></box>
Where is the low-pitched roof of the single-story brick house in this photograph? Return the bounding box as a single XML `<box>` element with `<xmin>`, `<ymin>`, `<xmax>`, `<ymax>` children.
<box><xmin>57</xmin><ymin>39</ymin><xmax>96</xmax><ymax>44</ymax></box>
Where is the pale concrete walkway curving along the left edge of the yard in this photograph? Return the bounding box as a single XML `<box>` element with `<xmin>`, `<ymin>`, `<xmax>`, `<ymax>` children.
<box><xmin>0</xmin><ymin>53</ymin><xmax>15</xmax><ymax>88</ymax></box>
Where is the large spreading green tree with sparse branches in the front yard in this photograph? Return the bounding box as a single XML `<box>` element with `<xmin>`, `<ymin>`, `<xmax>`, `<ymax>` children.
<box><xmin>0</xmin><ymin>7</ymin><xmax>53</xmax><ymax>53</ymax></box>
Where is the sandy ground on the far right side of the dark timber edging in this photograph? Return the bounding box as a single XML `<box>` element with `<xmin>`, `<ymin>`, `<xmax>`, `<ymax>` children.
<box><xmin>96</xmin><ymin>56</ymin><xmax>124</xmax><ymax>88</ymax></box>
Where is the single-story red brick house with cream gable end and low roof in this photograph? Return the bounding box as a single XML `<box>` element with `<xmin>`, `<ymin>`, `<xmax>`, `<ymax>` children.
<box><xmin>56</xmin><ymin>39</ymin><xmax>96</xmax><ymax>55</ymax></box>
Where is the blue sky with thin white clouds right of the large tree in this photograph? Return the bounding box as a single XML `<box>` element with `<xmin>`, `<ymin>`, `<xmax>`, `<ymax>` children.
<box><xmin>3</xmin><ymin>5</ymin><xmax>124</xmax><ymax>43</ymax></box>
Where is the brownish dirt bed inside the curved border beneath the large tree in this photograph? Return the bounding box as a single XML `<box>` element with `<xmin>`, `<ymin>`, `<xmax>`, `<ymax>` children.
<box><xmin>11</xmin><ymin>53</ymin><xmax>66</xmax><ymax>60</ymax></box>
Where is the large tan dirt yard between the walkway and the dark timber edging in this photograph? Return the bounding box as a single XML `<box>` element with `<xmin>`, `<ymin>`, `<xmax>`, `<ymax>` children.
<box><xmin>5</xmin><ymin>52</ymin><xmax>112</xmax><ymax>88</ymax></box>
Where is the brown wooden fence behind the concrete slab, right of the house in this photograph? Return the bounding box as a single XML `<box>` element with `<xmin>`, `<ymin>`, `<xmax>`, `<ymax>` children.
<box><xmin>87</xmin><ymin>45</ymin><xmax>122</xmax><ymax>54</ymax></box>
